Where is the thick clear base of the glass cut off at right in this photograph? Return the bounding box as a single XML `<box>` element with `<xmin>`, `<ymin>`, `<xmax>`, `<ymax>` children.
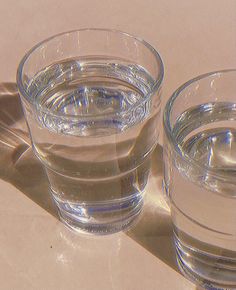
<box><xmin>175</xmin><ymin>237</ymin><xmax>236</xmax><ymax>290</ymax></box>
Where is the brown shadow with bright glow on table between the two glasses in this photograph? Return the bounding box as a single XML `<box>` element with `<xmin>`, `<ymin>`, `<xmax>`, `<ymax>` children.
<box><xmin>127</xmin><ymin>145</ymin><xmax>179</xmax><ymax>272</ymax></box>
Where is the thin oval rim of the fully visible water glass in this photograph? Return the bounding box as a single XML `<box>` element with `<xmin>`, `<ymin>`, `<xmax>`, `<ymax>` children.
<box><xmin>16</xmin><ymin>28</ymin><xmax>164</xmax><ymax>119</ymax></box>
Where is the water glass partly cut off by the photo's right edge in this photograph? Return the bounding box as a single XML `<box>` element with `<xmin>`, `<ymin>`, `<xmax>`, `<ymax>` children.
<box><xmin>164</xmin><ymin>70</ymin><xmax>236</xmax><ymax>289</ymax></box>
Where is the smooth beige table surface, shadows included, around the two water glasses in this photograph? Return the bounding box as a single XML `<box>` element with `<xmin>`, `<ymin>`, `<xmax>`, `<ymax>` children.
<box><xmin>0</xmin><ymin>0</ymin><xmax>236</xmax><ymax>290</ymax></box>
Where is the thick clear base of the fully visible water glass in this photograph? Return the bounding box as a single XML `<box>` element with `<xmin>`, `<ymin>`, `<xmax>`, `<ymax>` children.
<box><xmin>53</xmin><ymin>194</ymin><xmax>143</xmax><ymax>235</ymax></box>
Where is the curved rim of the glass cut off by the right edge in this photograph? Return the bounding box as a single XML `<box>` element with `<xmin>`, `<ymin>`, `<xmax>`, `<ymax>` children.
<box><xmin>163</xmin><ymin>68</ymin><xmax>236</xmax><ymax>178</ymax></box>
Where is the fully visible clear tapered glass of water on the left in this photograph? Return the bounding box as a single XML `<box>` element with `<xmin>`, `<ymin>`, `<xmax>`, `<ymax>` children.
<box><xmin>17</xmin><ymin>29</ymin><xmax>163</xmax><ymax>234</ymax></box>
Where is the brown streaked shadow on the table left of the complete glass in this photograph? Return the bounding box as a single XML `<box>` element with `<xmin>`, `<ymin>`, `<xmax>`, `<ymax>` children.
<box><xmin>0</xmin><ymin>83</ymin><xmax>57</xmax><ymax>217</ymax></box>
